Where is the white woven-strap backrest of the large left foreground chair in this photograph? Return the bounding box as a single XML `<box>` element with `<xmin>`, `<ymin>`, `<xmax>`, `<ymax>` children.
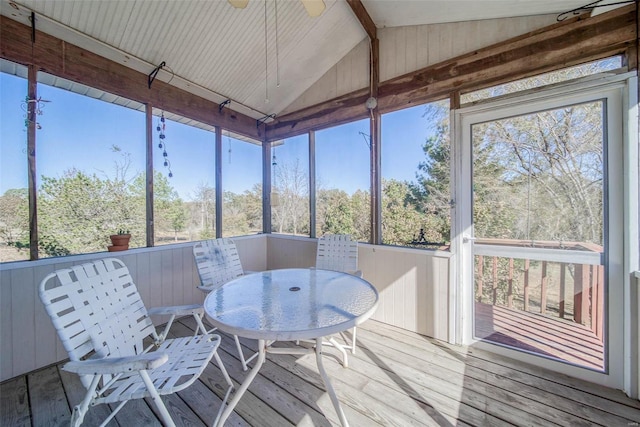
<box><xmin>40</xmin><ymin>258</ymin><xmax>155</xmax><ymax>386</ymax></box>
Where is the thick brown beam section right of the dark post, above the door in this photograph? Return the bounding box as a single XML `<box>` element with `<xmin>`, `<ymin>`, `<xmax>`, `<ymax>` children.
<box><xmin>378</xmin><ymin>5</ymin><xmax>636</xmax><ymax>112</ymax></box>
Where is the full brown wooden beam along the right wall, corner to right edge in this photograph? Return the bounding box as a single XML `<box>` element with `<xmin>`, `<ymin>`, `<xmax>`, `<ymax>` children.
<box><xmin>266</xmin><ymin>4</ymin><xmax>638</xmax><ymax>140</ymax></box>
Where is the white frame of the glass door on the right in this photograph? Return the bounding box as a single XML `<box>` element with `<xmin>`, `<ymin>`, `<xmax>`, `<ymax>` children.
<box><xmin>450</xmin><ymin>73</ymin><xmax>638</xmax><ymax>394</ymax></box>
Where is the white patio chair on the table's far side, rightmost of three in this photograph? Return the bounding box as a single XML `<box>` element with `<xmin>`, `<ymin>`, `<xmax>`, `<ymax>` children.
<box><xmin>316</xmin><ymin>234</ymin><xmax>362</xmax><ymax>354</ymax></box>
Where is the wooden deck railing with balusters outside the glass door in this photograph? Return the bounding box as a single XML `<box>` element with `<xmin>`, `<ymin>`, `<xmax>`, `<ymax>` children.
<box><xmin>474</xmin><ymin>239</ymin><xmax>604</xmax><ymax>340</ymax></box>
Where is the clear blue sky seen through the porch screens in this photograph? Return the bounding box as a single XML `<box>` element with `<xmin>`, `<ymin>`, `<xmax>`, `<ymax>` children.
<box><xmin>0</xmin><ymin>69</ymin><xmax>438</xmax><ymax>200</ymax></box>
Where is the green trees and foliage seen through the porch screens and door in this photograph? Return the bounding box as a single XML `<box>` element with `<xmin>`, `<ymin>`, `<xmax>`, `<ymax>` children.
<box><xmin>0</xmin><ymin>60</ymin><xmax>604</xmax><ymax>260</ymax></box>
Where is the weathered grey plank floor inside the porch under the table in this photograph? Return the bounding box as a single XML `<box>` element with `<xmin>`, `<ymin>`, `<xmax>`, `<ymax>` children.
<box><xmin>0</xmin><ymin>320</ymin><xmax>640</xmax><ymax>427</ymax></box>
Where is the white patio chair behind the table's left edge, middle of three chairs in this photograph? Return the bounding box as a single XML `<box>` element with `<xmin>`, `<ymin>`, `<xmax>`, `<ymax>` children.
<box><xmin>193</xmin><ymin>237</ymin><xmax>258</xmax><ymax>371</ymax></box>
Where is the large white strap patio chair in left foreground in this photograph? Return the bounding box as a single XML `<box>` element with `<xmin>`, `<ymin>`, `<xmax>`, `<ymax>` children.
<box><xmin>40</xmin><ymin>258</ymin><xmax>233</xmax><ymax>426</ymax></box>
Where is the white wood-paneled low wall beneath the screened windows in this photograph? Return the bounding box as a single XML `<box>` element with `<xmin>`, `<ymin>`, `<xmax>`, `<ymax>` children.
<box><xmin>0</xmin><ymin>235</ymin><xmax>450</xmax><ymax>381</ymax></box>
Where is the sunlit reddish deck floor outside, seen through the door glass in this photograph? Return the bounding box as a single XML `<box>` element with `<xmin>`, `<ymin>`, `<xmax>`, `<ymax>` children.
<box><xmin>475</xmin><ymin>302</ymin><xmax>604</xmax><ymax>371</ymax></box>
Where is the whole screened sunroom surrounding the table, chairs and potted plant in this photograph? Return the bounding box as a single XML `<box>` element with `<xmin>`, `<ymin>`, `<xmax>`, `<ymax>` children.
<box><xmin>0</xmin><ymin>0</ymin><xmax>640</xmax><ymax>425</ymax></box>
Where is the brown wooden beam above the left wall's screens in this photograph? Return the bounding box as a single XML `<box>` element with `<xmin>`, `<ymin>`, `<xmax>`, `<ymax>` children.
<box><xmin>0</xmin><ymin>16</ymin><xmax>264</xmax><ymax>141</ymax></box>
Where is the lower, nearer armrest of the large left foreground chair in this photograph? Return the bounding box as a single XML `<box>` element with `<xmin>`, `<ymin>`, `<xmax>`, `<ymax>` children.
<box><xmin>63</xmin><ymin>351</ymin><xmax>169</xmax><ymax>375</ymax></box>
